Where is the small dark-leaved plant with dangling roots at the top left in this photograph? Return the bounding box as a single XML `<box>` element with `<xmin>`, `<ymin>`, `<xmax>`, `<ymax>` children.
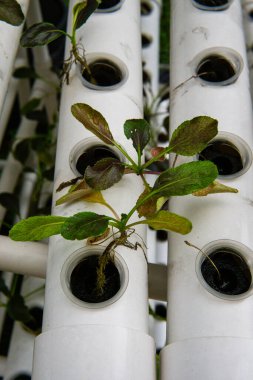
<box><xmin>20</xmin><ymin>0</ymin><xmax>101</xmax><ymax>83</ymax></box>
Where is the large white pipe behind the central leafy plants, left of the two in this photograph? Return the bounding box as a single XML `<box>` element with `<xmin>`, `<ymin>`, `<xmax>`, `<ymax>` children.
<box><xmin>33</xmin><ymin>1</ymin><xmax>155</xmax><ymax>380</ymax></box>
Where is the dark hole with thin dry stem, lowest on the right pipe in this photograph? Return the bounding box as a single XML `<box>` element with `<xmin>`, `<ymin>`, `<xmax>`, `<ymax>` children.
<box><xmin>201</xmin><ymin>248</ymin><xmax>252</xmax><ymax>295</ymax></box>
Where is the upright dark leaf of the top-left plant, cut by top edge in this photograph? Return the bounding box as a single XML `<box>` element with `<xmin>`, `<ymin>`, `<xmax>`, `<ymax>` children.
<box><xmin>73</xmin><ymin>0</ymin><xmax>101</xmax><ymax>31</ymax></box>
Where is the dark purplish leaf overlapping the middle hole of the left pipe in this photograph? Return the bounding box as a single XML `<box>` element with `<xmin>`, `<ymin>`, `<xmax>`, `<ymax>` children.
<box><xmin>84</xmin><ymin>157</ymin><xmax>125</xmax><ymax>190</ymax></box>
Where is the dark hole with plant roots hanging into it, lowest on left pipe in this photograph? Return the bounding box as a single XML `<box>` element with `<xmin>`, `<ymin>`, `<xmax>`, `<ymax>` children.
<box><xmin>70</xmin><ymin>255</ymin><xmax>120</xmax><ymax>303</ymax></box>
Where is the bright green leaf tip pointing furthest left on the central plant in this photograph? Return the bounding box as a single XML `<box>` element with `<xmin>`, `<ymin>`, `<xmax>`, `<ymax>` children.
<box><xmin>9</xmin><ymin>215</ymin><xmax>68</xmax><ymax>241</ymax></box>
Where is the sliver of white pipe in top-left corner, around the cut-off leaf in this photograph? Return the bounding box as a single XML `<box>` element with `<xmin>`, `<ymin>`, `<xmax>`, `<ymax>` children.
<box><xmin>0</xmin><ymin>0</ymin><xmax>29</xmax><ymax>116</ymax></box>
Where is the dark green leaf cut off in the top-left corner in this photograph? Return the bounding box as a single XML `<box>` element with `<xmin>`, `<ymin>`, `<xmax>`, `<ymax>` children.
<box><xmin>0</xmin><ymin>0</ymin><xmax>25</xmax><ymax>26</ymax></box>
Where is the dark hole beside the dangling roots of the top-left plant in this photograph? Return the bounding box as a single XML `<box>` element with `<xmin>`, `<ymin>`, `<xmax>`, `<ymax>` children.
<box><xmin>82</xmin><ymin>59</ymin><xmax>123</xmax><ymax>87</ymax></box>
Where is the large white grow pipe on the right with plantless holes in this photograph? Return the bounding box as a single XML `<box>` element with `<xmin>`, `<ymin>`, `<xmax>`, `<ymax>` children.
<box><xmin>161</xmin><ymin>0</ymin><xmax>253</xmax><ymax>380</ymax></box>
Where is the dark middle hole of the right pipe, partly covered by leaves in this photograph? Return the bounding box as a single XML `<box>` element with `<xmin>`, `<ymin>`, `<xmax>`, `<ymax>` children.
<box><xmin>199</xmin><ymin>140</ymin><xmax>243</xmax><ymax>175</ymax></box>
